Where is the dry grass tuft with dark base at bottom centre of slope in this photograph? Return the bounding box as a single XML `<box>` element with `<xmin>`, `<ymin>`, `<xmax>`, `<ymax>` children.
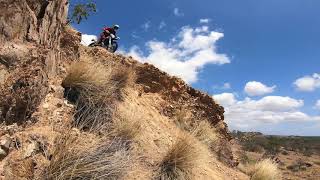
<box><xmin>156</xmin><ymin>134</ymin><xmax>207</xmax><ymax>180</ymax></box>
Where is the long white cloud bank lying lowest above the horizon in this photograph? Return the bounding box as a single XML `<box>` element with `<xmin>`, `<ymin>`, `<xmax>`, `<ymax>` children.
<box><xmin>213</xmin><ymin>93</ymin><xmax>320</xmax><ymax>131</ymax></box>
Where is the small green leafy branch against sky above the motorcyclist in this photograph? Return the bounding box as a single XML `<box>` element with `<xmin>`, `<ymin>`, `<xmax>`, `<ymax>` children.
<box><xmin>69</xmin><ymin>0</ymin><xmax>97</xmax><ymax>24</ymax></box>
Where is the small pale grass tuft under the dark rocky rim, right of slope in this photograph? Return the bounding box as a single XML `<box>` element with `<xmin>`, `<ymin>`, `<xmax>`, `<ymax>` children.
<box><xmin>191</xmin><ymin>121</ymin><xmax>219</xmax><ymax>149</ymax></box>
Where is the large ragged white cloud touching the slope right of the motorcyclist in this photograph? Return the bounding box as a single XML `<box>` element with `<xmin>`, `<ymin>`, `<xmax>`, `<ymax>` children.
<box><xmin>122</xmin><ymin>26</ymin><xmax>230</xmax><ymax>83</ymax></box>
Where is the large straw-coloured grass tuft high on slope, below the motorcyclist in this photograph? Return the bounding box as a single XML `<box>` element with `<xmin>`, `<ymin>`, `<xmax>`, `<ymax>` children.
<box><xmin>62</xmin><ymin>62</ymin><xmax>134</xmax><ymax>132</ymax></box>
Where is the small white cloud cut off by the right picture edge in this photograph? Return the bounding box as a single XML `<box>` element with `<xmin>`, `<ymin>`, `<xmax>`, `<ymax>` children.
<box><xmin>293</xmin><ymin>73</ymin><xmax>320</xmax><ymax>92</ymax></box>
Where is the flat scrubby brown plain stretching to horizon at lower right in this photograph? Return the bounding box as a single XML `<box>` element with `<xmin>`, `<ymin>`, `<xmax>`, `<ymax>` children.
<box><xmin>232</xmin><ymin>131</ymin><xmax>320</xmax><ymax>180</ymax></box>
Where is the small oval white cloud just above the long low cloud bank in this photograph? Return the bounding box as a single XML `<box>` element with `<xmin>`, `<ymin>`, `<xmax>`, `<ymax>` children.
<box><xmin>244</xmin><ymin>81</ymin><xmax>276</xmax><ymax>96</ymax></box>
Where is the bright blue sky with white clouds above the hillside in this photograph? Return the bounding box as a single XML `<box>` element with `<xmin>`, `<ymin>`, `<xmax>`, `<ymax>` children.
<box><xmin>74</xmin><ymin>0</ymin><xmax>320</xmax><ymax>135</ymax></box>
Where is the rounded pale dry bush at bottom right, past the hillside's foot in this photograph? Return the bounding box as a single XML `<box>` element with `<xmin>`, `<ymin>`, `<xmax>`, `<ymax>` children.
<box><xmin>249</xmin><ymin>159</ymin><xmax>281</xmax><ymax>180</ymax></box>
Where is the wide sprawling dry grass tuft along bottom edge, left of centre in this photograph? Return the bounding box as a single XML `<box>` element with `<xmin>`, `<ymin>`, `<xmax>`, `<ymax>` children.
<box><xmin>43</xmin><ymin>135</ymin><xmax>132</xmax><ymax>180</ymax></box>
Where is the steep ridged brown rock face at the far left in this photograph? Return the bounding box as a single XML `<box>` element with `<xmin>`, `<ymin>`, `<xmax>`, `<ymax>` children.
<box><xmin>0</xmin><ymin>0</ymin><xmax>68</xmax><ymax>124</ymax></box>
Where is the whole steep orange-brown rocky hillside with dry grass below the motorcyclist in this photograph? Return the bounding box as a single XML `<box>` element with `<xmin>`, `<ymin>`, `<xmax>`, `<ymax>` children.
<box><xmin>0</xmin><ymin>0</ymin><xmax>280</xmax><ymax>179</ymax></box>
